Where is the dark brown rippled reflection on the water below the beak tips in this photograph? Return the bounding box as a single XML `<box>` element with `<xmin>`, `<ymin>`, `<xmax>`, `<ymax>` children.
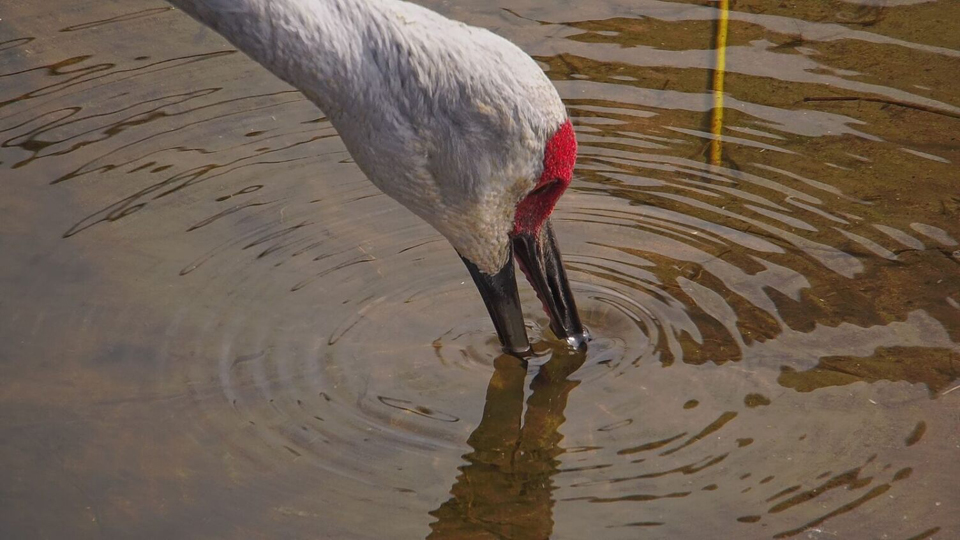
<box><xmin>427</xmin><ymin>351</ymin><xmax>586</xmax><ymax>540</ymax></box>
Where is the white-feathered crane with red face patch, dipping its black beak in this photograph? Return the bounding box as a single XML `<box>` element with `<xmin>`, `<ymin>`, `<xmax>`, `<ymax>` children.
<box><xmin>170</xmin><ymin>0</ymin><xmax>586</xmax><ymax>356</ymax></box>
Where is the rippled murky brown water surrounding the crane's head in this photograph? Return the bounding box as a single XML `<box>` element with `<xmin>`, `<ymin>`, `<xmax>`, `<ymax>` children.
<box><xmin>0</xmin><ymin>0</ymin><xmax>960</xmax><ymax>540</ymax></box>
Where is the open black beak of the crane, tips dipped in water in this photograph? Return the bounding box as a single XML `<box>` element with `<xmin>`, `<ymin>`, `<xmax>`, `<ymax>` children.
<box><xmin>461</xmin><ymin>220</ymin><xmax>587</xmax><ymax>357</ymax></box>
